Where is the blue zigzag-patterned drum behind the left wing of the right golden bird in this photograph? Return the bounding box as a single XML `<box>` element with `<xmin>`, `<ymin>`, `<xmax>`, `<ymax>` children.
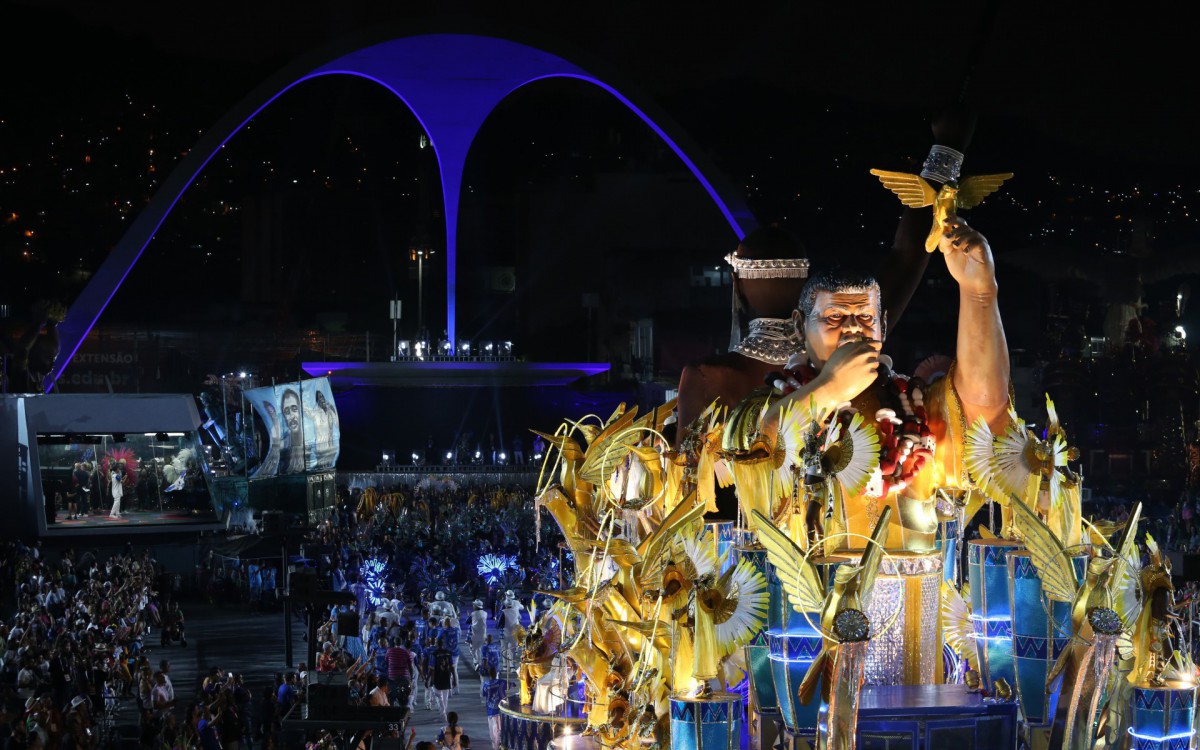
<box><xmin>1008</xmin><ymin>550</ymin><xmax>1088</xmax><ymax>726</ymax></box>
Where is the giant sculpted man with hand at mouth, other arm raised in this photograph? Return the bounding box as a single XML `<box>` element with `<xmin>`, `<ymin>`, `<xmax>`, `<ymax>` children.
<box><xmin>763</xmin><ymin>218</ymin><xmax>1009</xmax><ymax>551</ymax></box>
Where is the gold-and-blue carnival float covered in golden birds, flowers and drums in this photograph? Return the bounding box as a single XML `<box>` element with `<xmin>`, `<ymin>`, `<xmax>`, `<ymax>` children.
<box><xmin>502</xmin><ymin>160</ymin><xmax>1196</xmax><ymax>750</ymax></box>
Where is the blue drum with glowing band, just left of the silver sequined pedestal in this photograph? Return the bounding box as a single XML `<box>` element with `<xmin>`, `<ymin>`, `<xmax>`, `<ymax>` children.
<box><xmin>767</xmin><ymin>557</ymin><xmax>847</xmax><ymax>737</ymax></box>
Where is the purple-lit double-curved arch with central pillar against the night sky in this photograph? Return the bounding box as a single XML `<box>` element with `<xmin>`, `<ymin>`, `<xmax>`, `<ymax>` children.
<box><xmin>46</xmin><ymin>34</ymin><xmax>755</xmax><ymax>390</ymax></box>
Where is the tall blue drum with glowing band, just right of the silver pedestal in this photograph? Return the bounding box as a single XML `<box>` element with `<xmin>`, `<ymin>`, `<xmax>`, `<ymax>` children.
<box><xmin>967</xmin><ymin>539</ymin><xmax>1022</xmax><ymax>690</ymax></box>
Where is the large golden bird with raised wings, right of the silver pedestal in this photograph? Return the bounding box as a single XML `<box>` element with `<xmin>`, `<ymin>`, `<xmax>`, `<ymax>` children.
<box><xmin>1010</xmin><ymin>496</ymin><xmax>1141</xmax><ymax>750</ymax></box>
